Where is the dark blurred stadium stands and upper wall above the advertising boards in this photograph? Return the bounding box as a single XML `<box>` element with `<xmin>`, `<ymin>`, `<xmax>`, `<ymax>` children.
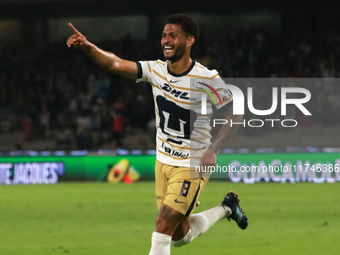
<box><xmin>0</xmin><ymin>0</ymin><xmax>340</xmax><ymax>155</ymax></box>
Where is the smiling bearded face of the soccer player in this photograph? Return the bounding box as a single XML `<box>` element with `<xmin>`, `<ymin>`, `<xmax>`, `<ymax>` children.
<box><xmin>161</xmin><ymin>24</ymin><xmax>188</xmax><ymax>62</ymax></box>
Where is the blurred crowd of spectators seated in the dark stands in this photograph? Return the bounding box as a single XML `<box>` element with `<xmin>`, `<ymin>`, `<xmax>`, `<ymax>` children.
<box><xmin>0</xmin><ymin>28</ymin><xmax>340</xmax><ymax>149</ymax></box>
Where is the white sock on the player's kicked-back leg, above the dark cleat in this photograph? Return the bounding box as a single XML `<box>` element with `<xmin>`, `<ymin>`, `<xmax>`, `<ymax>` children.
<box><xmin>171</xmin><ymin>205</ymin><xmax>231</xmax><ymax>247</ymax></box>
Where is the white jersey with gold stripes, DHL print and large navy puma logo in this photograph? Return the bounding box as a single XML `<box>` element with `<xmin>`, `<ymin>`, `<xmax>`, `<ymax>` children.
<box><xmin>137</xmin><ymin>60</ymin><xmax>232</xmax><ymax>167</ymax></box>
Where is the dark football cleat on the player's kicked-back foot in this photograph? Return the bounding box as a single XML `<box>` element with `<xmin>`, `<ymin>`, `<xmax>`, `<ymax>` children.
<box><xmin>221</xmin><ymin>191</ymin><xmax>248</xmax><ymax>229</ymax></box>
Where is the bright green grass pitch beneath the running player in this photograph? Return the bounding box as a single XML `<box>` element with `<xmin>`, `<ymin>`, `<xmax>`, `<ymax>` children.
<box><xmin>0</xmin><ymin>181</ymin><xmax>340</xmax><ymax>255</ymax></box>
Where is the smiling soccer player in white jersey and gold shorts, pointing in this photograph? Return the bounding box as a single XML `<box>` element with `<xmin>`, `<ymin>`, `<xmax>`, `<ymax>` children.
<box><xmin>67</xmin><ymin>14</ymin><xmax>248</xmax><ymax>255</ymax></box>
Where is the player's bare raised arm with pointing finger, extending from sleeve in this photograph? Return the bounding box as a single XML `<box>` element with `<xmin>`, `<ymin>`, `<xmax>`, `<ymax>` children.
<box><xmin>66</xmin><ymin>23</ymin><xmax>138</xmax><ymax>80</ymax></box>
